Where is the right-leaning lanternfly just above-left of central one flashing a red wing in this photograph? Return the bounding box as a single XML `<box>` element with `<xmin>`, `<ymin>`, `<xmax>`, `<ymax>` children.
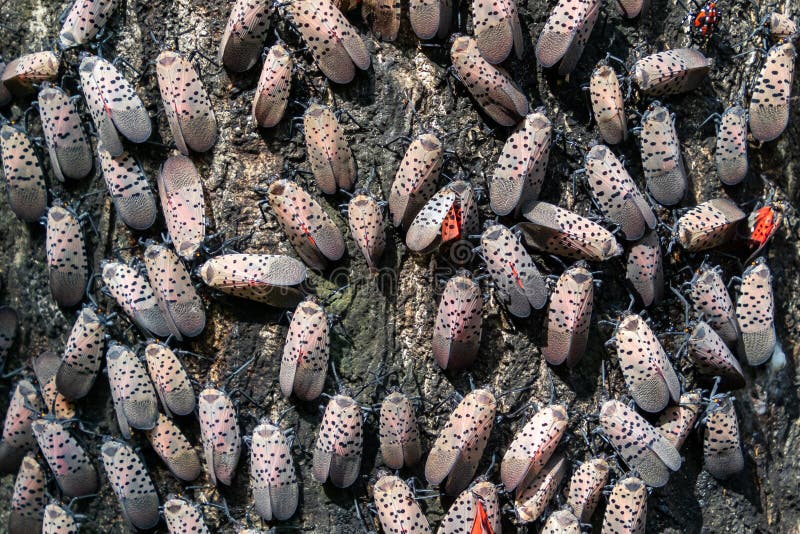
<box><xmin>389</xmin><ymin>134</ymin><xmax>444</xmax><ymax>228</ymax></box>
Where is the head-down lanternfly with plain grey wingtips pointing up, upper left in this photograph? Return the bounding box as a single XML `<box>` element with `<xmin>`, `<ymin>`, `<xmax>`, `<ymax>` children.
<box><xmin>157</xmin><ymin>154</ymin><xmax>206</xmax><ymax>262</ymax></box>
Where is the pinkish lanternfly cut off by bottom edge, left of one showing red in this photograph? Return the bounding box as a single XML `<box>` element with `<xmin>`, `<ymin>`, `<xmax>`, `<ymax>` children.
<box><xmin>373</xmin><ymin>474</ymin><xmax>431</xmax><ymax>534</ymax></box>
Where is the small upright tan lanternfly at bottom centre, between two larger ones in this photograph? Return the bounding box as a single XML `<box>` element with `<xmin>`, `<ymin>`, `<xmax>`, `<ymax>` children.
<box><xmin>379</xmin><ymin>391</ymin><xmax>422</xmax><ymax>469</ymax></box>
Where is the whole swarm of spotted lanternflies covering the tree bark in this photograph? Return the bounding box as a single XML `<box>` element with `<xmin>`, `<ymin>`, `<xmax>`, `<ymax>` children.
<box><xmin>0</xmin><ymin>0</ymin><xmax>798</xmax><ymax>534</ymax></box>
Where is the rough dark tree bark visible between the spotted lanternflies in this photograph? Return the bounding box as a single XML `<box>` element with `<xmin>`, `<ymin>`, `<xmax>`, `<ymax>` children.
<box><xmin>0</xmin><ymin>0</ymin><xmax>800</xmax><ymax>532</ymax></box>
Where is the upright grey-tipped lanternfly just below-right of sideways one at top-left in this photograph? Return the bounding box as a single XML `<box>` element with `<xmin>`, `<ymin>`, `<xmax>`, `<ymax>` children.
<box><xmin>39</xmin><ymin>85</ymin><xmax>92</xmax><ymax>182</ymax></box>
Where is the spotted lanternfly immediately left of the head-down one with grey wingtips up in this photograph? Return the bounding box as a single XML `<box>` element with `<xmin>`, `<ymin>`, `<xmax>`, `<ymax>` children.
<box><xmin>97</xmin><ymin>147</ymin><xmax>158</xmax><ymax>230</ymax></box>
